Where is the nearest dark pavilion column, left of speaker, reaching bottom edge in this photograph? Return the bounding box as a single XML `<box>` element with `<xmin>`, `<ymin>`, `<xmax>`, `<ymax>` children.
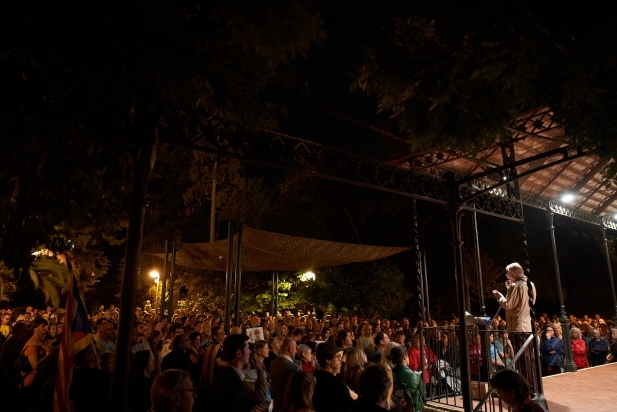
<box><xmin>450</xmin><ymin>207</ymin><xmax>473</xmax><ymax>412</ymax></box>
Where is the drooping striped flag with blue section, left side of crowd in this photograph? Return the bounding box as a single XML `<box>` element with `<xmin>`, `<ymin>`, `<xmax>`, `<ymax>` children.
<box><xmin>54</xmin><ymin>276</ymin><xmax>92</xmax><ymax>412</ymax></box>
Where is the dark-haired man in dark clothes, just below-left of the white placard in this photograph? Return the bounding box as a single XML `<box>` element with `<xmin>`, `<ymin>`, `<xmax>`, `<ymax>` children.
<box><xmin>209</xmin><ymin>334</ymin><xmax>251</xmax><ymax>412</ymax></box>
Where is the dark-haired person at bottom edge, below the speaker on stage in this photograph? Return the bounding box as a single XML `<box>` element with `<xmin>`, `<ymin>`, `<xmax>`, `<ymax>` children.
<box><xmin>490</xmin><ymin>369</ymin><xmax>548</xmax><ymax>412</ymax></box>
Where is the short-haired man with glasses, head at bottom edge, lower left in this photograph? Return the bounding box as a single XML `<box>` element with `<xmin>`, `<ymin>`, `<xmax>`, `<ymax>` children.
<box><xmin>150</xmin><ymin>369</ymin><xmax>196</xmax><ymax>412</ymax></box>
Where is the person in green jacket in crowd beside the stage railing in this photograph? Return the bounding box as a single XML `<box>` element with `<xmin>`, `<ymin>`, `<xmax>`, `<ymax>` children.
<box><xmin>390</xmin><ymin>346</ymin><xmax>424</xmax><ymax>411</ymax></box>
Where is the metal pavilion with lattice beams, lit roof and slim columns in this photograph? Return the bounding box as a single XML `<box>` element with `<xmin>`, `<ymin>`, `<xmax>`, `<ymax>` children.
<box><xmin>116</xmin><ymin>108</ymin><xmax>617</xmax><ymax>411</ymax></box>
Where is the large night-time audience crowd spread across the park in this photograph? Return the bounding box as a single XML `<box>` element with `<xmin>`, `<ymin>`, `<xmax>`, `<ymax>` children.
<box><xmin>0</xmin><ymin>302</ymin><xmax>617</xmax><ymax>412</ymax></box>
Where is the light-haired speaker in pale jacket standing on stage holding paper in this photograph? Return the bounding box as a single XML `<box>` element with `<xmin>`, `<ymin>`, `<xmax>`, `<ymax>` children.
<box><xmin>493</xmin><ymin>262</ymin><xmax>539</xmax><ymax>392</ymax></box>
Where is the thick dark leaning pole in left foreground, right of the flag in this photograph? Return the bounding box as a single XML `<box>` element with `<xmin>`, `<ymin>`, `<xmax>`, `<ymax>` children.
<box><xmin>106</xmin><ymin>127</ymin><xmax>158</xmax><ymax>411</ymax></box>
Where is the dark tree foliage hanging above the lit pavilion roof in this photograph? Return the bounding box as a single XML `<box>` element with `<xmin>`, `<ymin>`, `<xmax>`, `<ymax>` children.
<box><xmin>352</xmin><ymin>0</ymin><xmax>617</xmax><ymax>176</ymax></box>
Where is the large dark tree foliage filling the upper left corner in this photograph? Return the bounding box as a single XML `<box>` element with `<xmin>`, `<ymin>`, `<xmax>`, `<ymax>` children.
<box><xmin>0</xmin><ymin>0</ymin><xmax>325</xmax><ymax>284</ymax></box>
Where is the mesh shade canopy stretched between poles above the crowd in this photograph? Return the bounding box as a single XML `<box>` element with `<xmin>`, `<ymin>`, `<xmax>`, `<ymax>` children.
<box><xmin>155</xmin><ymin>226</ymin><xmax>409</xmax><ymax>272</ymax></box>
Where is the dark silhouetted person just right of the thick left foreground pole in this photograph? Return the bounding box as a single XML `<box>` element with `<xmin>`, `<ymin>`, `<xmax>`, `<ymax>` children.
<box><xmin>126</xmin><ymin>350</ymin><xmax>154</xmax><ymax>412</ymax></box>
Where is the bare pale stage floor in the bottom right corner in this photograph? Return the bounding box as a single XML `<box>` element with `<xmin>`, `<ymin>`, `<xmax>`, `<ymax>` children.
<box><xmin>542</xmin><ymin>363</ymin><xmax>617</xmax><ymax>412</ymax></box>
